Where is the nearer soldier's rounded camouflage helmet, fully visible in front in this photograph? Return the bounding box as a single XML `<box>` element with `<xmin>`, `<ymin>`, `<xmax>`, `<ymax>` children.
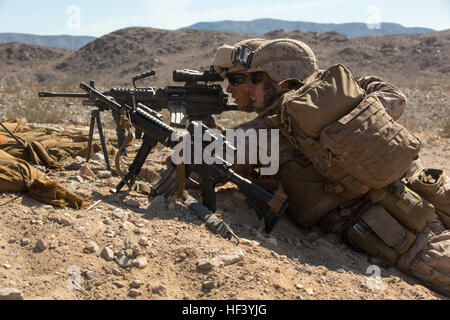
<box><xmin>247</xmin><ymin>39</ymin><xmax>318</xmax><ymax>82</ymax></box>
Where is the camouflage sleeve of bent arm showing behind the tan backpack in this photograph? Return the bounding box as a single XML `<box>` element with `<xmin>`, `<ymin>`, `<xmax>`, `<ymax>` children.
<box><xmin>358</xmin><ymin>76</ymin><xmax>406</xmax><ymax>120</ymax></box>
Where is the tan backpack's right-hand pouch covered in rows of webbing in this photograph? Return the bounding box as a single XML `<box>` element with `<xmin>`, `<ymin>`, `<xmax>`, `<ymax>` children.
<box><xmin>320</xmin><ymin>95</ymin><xmax>420</xmax><ymax>189</ymax></box>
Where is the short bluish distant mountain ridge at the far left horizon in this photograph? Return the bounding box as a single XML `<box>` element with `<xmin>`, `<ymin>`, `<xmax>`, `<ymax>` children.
<box><xmin>0</xmin><ymin>33</ymin><xmax>96</xmax><ymax>50</ymax></box>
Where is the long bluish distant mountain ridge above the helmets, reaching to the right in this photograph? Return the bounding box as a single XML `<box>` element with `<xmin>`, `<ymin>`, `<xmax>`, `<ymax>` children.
<box><xmin>181</xmin><ymin>19</ymin><xmax>435</xmax><ymax>38</ymax></box>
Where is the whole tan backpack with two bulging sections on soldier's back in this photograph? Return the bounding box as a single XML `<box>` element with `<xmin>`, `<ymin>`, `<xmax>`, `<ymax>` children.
<box><xmin>268</xmin><ymin>64</ymin><xmax>420</xmax><ymax>200</ymax></box>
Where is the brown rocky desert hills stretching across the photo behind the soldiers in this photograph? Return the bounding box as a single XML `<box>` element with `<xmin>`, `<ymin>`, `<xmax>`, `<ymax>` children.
<box><xmin>0</xmin><ymin>28</ymin><xmax>450</xmax><ymax>85</ymax></box>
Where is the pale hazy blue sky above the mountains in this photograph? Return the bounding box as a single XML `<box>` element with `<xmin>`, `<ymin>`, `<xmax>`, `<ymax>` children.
<box><xmin>0</xmin><ymin>0</ymin><xmax>450</xmax><ymax>37</ymax></box>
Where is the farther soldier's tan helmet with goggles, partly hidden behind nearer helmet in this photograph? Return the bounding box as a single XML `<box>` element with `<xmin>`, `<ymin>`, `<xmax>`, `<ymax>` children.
<box><xmin>212</xmin><ymin>38</ymin><xmax>268</xmax><ymax>76</ymax></box>
